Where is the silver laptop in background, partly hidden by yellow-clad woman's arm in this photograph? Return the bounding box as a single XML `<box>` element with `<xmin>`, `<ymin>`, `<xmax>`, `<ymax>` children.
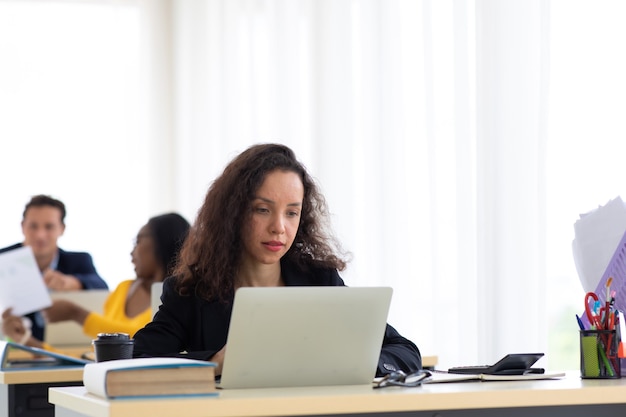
<box><xmin>44</xmin><ymin>290</ymin><xmax>109</xmax><ymax>347</ymax></box>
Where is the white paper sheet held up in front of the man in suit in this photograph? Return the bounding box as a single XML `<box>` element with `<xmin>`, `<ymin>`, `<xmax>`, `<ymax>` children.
<box><xmin>0</xmin><ymin>246</ymin><xmax>52</xmax><ymax>316</ymax></box>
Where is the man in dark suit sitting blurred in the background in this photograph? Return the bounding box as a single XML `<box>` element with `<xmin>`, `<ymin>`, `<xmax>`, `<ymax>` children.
<box><xmin>0</xmin><ymin>195</ymin><xmax>108</xmax><ymax>340</ymax></box>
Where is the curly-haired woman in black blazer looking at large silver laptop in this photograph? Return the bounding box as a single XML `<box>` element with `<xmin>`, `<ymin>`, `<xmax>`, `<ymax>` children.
<box><xmin>134</xmin><ymin>144</ymin><xmax>421</xmax><ymax>375</ymax></box>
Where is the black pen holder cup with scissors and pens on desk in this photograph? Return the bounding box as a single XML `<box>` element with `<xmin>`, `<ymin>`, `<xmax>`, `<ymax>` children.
<box><xmin>580</xmin><ymin>330</ymin><xmax>622</xmax><ymax>379</ymax></box>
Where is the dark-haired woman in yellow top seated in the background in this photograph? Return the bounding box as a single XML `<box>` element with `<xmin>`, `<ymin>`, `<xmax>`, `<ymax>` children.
<box><xmin>2</xmin><ymin>213</ymin><xmax>189</xmax><ymax>350</ymax></box>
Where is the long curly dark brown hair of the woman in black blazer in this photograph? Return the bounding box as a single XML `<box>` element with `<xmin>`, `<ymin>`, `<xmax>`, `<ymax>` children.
<box><xmin>174</xmin><ymin>144</ymin><xmax>346</xmax><ymax>301</ymax></box>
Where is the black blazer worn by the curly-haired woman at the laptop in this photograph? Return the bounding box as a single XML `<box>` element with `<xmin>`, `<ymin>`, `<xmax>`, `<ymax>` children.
<box><xmin>133</xmin><ymin>262</ymin><xmax>422</xmax><ymax>376</ymax></box>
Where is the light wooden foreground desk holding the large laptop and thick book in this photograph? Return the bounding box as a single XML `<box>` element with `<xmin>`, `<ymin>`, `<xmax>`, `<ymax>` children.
<box><xmin>49</xmin><ymin>374</ymin><xmax>626</xmax><ymax>417</ymax></box>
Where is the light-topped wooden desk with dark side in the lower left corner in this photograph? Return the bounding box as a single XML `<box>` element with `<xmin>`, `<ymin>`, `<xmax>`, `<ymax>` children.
<box><xmin>0</xmin><ymin>366</ymin><xmax>83</xmax><ymax>417</ymax></box>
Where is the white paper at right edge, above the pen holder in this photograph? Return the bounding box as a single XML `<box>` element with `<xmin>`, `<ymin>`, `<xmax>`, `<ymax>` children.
<box><xmin>572</xmin><ymin>196</ymin><xmax>626</xmax><ymax>292</ymax></box>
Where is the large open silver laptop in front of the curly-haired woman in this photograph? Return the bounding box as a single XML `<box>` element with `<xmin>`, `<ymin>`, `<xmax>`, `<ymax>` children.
<box><xmin>219</xmin><ymin>287</ymin><xmax>392</xmax><ymax>389</ymax></box>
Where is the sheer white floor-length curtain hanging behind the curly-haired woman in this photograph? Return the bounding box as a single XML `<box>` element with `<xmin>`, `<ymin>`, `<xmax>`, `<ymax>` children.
<box><xmin>163</xmin><ymin>0</ymin><xmax>548</xmax><ymax>366</ymax></box>
